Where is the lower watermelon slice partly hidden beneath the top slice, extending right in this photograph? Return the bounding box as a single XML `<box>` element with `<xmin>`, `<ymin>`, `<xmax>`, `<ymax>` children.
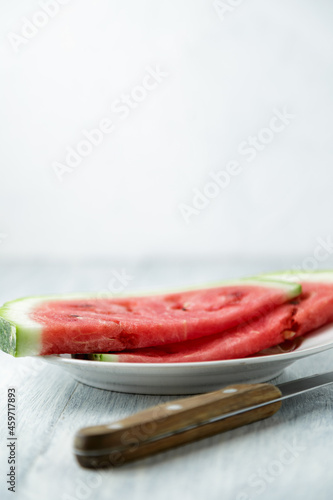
<box><xmin>85</xmin><ymin>272</ymin><xmax>333</xmax><ymax>363</ymax></box>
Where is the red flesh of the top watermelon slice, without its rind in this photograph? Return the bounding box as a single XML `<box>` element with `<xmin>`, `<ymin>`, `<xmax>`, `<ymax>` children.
<box><xmin>32</xmin><ymin>287</ymin><xmax>294</xmax><ymax>354</ymax></box>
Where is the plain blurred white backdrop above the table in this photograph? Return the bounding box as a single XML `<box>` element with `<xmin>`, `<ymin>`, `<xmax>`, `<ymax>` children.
<box><xmin>0</xmin><ymin>0</ymin><xmax>333</xmax><ymax>258</ymax></box>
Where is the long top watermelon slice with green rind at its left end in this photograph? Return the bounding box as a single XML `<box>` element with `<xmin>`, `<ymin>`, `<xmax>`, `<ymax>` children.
<box><xmin>0</xmin><ymin>278</ymin><xmax>301</xmax><ymax>356</ymax></box>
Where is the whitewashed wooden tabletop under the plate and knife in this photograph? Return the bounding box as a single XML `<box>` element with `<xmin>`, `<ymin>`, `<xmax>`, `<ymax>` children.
<box><xmin>0</xmin><ymin>261</ymin><xmax>333</xmax><ymax>500</ymax></box>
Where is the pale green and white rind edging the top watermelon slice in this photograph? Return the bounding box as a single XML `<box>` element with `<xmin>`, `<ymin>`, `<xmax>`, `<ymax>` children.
<box><xmin>0</xmin><ymin>277</ymin><xmax>301</xmax><ymax>357</ymax></box>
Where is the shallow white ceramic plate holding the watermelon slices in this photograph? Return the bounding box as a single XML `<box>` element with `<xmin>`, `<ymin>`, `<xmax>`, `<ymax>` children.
<box><xmin>42</xmin><ymin>325</ymin><xmax>333</xmax><ymax>394</ymax></box>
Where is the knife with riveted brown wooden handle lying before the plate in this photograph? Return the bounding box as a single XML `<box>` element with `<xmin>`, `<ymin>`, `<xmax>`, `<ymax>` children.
<box><xmin>74</xmin><ymin>372</ymin><xmax>333</xmax><ymax>469</ymax></box>
